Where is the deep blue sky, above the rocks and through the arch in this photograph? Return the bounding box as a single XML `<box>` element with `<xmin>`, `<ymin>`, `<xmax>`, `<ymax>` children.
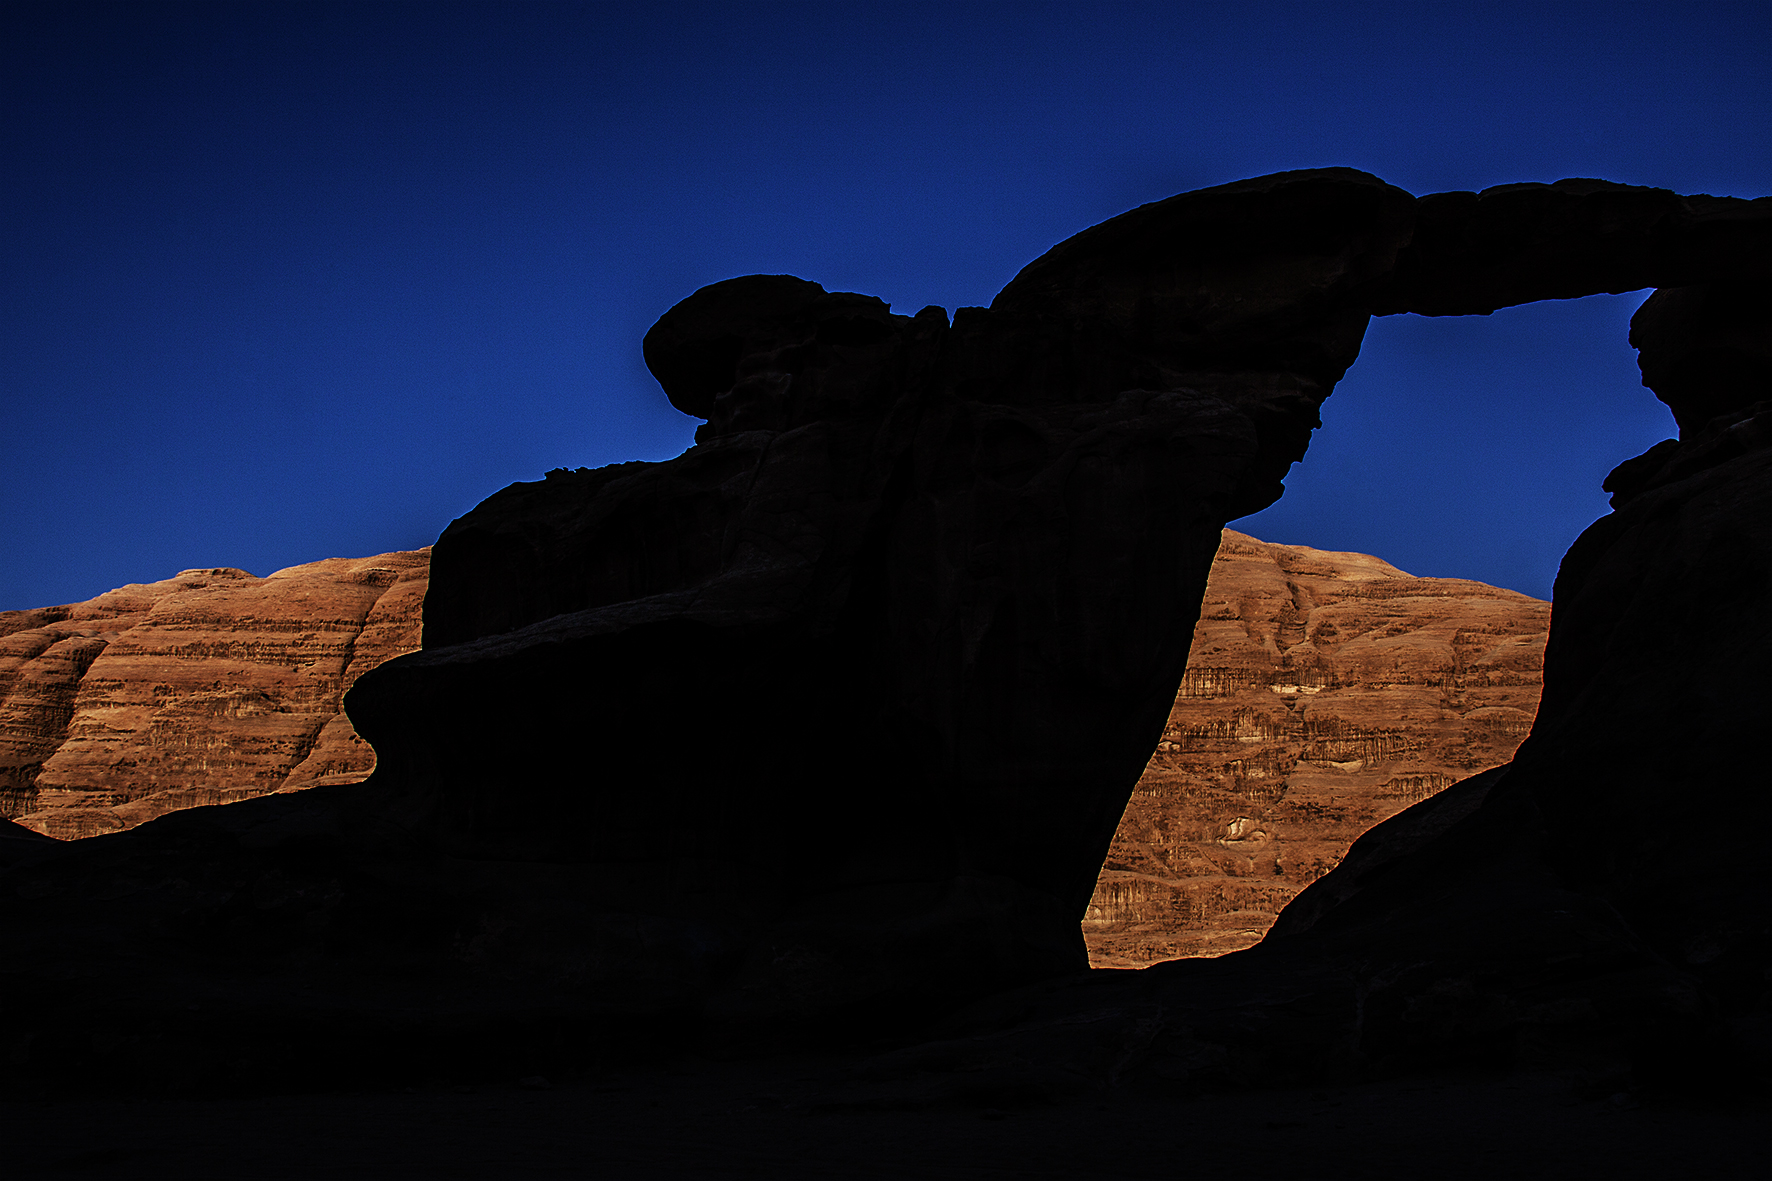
<box><xmin>0</xmin><ymin>0</ymin><xmax>1772</xmax><ymax>608</ymax></box>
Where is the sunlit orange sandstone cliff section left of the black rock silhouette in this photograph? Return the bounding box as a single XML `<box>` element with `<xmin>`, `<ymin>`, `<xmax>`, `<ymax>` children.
<box><xmin>0</xmin><ymin>550</ymin><xmax>429</xmax><ymax>837</ymax></box>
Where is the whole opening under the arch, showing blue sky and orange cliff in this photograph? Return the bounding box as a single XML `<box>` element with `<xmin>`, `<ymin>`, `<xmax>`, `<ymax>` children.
<box><xmin>1083</xmin><ymin>291</ymin><xmax>1678</xmax><ymax>966</ymax></box>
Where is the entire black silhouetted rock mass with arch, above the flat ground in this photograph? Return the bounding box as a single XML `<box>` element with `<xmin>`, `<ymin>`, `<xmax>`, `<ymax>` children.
<box><xmin>0</xmin><ymin>170</ymin><xmax>1772</xmax><ymax>1085</ymax></box>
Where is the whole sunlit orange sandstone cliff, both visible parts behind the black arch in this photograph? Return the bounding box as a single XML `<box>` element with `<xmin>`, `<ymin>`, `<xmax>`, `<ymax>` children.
<box><xmin>0</xmin><ymin>530</ymin><xmax>1549</xmax><ymax>966</ymax></box>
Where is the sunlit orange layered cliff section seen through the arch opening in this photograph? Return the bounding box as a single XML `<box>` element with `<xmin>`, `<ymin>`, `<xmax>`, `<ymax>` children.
<box><xmin>1083</xmin><ymin>530</ymin><xmax>1551</xmax><ymax>966</ymax></box>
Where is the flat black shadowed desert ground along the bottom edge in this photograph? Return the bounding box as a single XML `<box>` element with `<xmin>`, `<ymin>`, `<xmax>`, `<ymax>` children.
<box><xmin>9</xmin><ymin>1060</ymin><xmax>1767</xmax><ymax>1181</ymax></box>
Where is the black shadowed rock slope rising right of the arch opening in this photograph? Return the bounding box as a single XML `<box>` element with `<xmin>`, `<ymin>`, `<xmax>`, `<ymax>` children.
<box><xmin>864</xmin><ymin>393</ymin><xmax>1772</xmax><ymax>1101</ymax></box>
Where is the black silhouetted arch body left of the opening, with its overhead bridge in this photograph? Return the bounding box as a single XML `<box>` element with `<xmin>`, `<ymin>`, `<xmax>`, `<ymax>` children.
<box><xmin>353</xmin><ymin>168</ymin><xmax>1772</xmax><ymax>1009</ymax></box>
